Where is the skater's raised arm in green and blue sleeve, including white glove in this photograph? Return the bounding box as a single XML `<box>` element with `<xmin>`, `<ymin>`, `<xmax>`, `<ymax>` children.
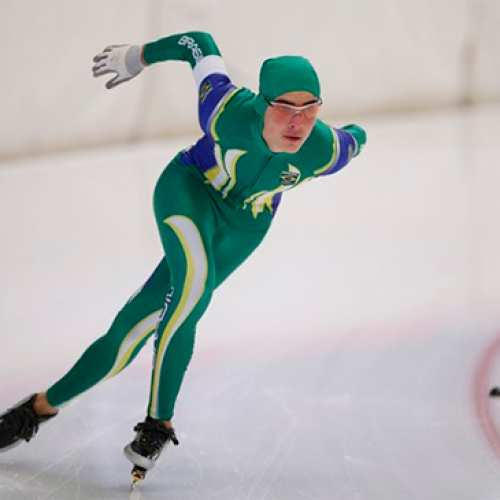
<box><xmin>92</xmin><ymin>31</ymin><xmax>235</xmax><ymax>131</ymax></box>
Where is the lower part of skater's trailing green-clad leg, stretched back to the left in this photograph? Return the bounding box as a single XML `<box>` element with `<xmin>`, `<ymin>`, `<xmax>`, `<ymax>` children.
<box><xmin>47</xmin><ymin>259</ymin><xmax>171</xmax><ymax>408</ymax></box>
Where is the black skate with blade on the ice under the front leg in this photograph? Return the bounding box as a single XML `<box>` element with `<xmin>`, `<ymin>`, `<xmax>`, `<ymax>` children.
<box><xmin>123</xmin><ymin>417</ymin><xmax>179</xmax><ymax>485</ymax></box>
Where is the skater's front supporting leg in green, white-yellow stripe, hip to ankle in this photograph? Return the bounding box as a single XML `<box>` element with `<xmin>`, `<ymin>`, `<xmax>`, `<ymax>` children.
<box><xmin>148</xmin><ymin>163</ymin><xmax>216</xmax><ymax>421</ymax></box>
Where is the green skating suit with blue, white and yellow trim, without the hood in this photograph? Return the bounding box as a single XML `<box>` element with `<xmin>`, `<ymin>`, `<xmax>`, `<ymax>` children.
<box><xmin>47</xmin><ymin>32</ymin><xmax>366</xmax><ymax>420</ymax></box>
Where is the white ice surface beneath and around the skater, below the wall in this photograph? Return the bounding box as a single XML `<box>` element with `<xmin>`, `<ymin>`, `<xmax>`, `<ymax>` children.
<box><xmin>0</xmin><ymin>106</ymin><xmax>500</xmax><ymax>500</ymax></box>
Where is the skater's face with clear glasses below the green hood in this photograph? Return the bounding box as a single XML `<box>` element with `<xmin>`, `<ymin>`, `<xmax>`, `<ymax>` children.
<box><xmin>262</xmin><ymin>91</ymin><xmax>321</xmax><ymax>153</ymax></box>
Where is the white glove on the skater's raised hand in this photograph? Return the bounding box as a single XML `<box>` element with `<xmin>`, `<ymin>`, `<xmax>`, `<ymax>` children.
<box><xmin>92</xmin><ymin>45</ymin><xmax>146</xmax><ymax>89</ymax></box>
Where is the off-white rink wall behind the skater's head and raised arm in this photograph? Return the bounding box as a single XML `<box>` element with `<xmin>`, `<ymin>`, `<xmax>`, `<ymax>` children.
<box><xmin>0</xmin><ymin>0</ymin><xmax>500</xmax><ymax>159</ymax></box>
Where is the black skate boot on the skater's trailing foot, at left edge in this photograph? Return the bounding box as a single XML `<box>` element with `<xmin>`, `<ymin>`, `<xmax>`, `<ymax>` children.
<box><xmin>0</xmin><ymin>394</ymin><xmax>56</xmax><ymax>452</ymax></box>
